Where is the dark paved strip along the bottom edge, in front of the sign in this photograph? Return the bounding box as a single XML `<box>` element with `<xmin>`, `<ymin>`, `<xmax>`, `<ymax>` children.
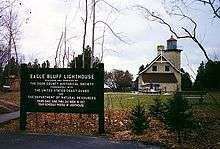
<box><xmin>0</xmin><ymin>134</ymin><xmax>160</xmax><ymax>149</ymax></box>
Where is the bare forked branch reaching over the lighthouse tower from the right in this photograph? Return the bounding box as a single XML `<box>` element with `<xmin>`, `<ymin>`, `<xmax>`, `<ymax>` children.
<box><xmin>135</xmin><ymin>5</ymin><xmax>210</xmax><ymax>61</ymax></box>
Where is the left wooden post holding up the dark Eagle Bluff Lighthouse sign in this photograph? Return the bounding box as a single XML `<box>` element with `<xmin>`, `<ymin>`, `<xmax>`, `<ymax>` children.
<box><xmin>20</xmin><ymin>64</ymin><xmax>27</xmax><ymax>131</ymax></box>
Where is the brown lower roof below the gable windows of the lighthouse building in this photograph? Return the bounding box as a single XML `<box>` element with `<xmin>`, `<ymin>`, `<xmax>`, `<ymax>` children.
<box><xmin>142</xmin><ymin>73</ymin><xmax>177</xmax><ymax>83</ymax></box>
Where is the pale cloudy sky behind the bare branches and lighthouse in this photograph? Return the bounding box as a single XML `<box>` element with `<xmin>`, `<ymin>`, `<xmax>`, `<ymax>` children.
<box><xmin>14</xmin><ymin>0</ymin><xmax>220</xmax><ymax>78</ymax></box>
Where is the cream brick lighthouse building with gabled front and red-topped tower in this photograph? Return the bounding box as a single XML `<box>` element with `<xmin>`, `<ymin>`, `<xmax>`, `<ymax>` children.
<box><xmin>138</xmin><ymin>36</ymin><xmax>182</xmax><ymax>93</ymax></box>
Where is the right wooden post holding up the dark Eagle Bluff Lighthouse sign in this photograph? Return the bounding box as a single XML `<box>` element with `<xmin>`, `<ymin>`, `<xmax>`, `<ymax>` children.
<box><xmin>98</xmin><ymin>63</ymin><xmax>105</xmax><ymax>134</ymax></box>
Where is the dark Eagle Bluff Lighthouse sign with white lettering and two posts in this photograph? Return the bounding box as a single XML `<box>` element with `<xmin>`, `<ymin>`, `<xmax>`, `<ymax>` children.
<box><xmin>20</xmin><ymin>64</ymin><xmax>104</xmax><ymax>133</ymax></box>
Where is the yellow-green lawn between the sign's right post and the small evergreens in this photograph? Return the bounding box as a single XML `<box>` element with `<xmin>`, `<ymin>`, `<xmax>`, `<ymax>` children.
<box><xmin>105</xmin><ymin>93</ymin><xmax>171</xmax><ymax>110</ymax></box>
